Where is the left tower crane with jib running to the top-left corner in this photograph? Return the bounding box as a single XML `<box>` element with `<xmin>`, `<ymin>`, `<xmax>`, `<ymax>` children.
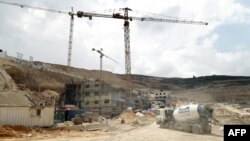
<box><xmin>0</xmin><ymin>1</ymin><xmax>75</xmax><ymax>66</ymax></box>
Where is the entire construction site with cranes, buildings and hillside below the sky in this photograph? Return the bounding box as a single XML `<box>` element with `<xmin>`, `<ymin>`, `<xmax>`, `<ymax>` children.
<box><xmin>0</xmin><ymin>1</ymin><xmax>250</xmax><ymax>141</ymax></box>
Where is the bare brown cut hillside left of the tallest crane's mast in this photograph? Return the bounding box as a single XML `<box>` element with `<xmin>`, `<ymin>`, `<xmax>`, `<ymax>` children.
<box><xmin>0</xmin><ymin>59</ymin><xmax>143</xmax><ymax>93</ymax></box>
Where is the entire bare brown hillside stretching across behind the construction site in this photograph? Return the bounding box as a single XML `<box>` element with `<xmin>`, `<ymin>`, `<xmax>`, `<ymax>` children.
<box><xmin>0</xmin><ymin>59</ymin><xmax>250</xmax><ymax>103</ymax></box>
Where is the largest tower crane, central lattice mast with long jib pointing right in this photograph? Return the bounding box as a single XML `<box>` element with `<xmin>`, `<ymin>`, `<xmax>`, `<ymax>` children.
<box><xmin>76</xmin><ymin>7</ymin><xmax>208</xmax><ymax>105</ymax></box>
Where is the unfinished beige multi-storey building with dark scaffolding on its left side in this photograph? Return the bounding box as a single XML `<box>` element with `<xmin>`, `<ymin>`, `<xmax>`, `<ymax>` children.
<box><xmin>60</xmin><ymin>80</ymin><xmax>126</xmax><ymax>116</ymax></box>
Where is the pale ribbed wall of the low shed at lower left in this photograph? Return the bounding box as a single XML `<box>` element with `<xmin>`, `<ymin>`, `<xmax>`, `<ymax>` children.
<box><xmin>0</xmin><ymin>107</ymin><xmax>54</xmax><ymax>127</ymax></box>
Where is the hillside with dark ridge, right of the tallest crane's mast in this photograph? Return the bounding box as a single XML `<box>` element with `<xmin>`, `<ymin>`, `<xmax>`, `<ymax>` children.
<box><xmin>133</xmin><ymin>75</ymin><xmax>250</xmax><ymax>103</ymax></box>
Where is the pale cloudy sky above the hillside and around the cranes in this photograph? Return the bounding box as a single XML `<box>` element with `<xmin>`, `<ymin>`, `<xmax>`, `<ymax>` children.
<box><xmin>0</xmin><ymin>0</ymin><xmax>250</xmax><ymax>77</ymax></box>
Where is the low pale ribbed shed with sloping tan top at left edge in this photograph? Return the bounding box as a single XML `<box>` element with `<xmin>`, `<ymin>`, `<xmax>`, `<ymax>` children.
<box><xmin>0</xmin><ymin>92</ymin><xmax>55</xmax><ymax>127</ymax></box>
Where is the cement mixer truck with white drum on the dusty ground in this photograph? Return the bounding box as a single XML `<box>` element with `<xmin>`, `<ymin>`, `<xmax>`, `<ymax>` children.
<box><xmin>156</xmin><ymin>104</ymin><xmax>213</xmax><ymax>134</ymax></box>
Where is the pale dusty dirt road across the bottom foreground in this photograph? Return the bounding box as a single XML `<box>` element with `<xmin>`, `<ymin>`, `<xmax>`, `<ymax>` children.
<box><xmin>33</xmin><ymin>123</ymin><xmax>223</xmax><ymax>141</ymax></box>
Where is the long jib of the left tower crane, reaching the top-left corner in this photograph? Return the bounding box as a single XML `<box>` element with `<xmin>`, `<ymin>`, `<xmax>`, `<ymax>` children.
<box><xmin>0</xmin><ymin>1</ymin><xmax>69</xmax><ymax>14</ymax></box>
